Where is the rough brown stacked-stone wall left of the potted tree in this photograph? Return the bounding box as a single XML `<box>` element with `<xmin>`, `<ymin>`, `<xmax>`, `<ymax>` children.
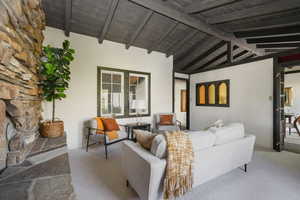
<box><xmin>0</xmin><ymin>0</ymin><xmax>45</xmax><ymax>169</ymax></box>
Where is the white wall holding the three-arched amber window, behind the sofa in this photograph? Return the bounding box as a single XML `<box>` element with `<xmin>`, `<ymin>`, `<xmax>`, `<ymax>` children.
<box><xmin>190</xmin><ymin>59</ymin><xmax>273</xmax><ymax>148</ymax></box>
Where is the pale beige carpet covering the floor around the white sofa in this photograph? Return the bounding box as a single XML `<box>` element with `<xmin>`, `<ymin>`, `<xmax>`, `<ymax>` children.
<box><xmin>70</xmin><ymin>144</ymin><xmax>300</xmax><ymax>200</ymax></box>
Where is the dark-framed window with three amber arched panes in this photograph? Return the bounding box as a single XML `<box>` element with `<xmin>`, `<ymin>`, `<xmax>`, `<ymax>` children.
<box><xmin>196</xmin><ymin>80</ymin><xmax>230</xmax><ymax>107</ymax></box>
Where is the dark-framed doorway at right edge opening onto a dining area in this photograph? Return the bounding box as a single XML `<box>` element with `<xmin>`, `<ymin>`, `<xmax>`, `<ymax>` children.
<box><xmin>273</xmin><ymin>52</ymin><xmax>300</xmax><ymax>153</ymax></box>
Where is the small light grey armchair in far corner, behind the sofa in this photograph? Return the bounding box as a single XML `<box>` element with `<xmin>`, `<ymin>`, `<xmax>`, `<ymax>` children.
<box><xmin>154</xmin><ymin>113</ymin><xmax>181</xmax><ymax>133</ymax></box>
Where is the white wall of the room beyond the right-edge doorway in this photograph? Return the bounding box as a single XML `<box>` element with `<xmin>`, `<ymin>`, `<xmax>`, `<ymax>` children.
<box><xmin>284</xmin><ymin>73</ymin><xmax>300</xmax><ymax>114</ymax></box>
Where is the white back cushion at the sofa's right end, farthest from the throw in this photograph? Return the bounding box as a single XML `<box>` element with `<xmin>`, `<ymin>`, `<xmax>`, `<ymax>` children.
<box><xmin>209</xmin><ymin>123</ymin><xmax>245</xmax><ymax>145</ymax></box>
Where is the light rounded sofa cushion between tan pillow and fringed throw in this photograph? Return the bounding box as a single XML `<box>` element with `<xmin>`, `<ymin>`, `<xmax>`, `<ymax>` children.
<box><xmin>151</xmin><ymin>134</ymin><xmax>167</xmax><ymax>159</ymax></box>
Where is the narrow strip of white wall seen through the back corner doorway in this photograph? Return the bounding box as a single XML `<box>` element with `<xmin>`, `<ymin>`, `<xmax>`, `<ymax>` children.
<box><xmin>174</xmin><ymin>79</ymin><xmax>186</xmax><ymax>126</ymax></box>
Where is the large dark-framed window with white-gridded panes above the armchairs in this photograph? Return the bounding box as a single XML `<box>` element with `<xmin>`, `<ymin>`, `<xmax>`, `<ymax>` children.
<box><xmin>97</xmin><ymin>67</ymin><xmax>151</xmax><ymax>118</ymax></box>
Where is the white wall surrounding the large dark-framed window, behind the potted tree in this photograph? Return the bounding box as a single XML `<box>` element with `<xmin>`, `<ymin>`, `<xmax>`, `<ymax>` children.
<box><xmin>44</xmin><ymin>27</ymin><xmax>173</xmax><ymax>148</ymax></box>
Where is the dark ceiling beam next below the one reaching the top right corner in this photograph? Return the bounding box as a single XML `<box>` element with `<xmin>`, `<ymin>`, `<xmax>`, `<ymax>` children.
<box><xmin>234</xmin><ymin>25</ymin><xmax>300</xmax><ymax>38</ymax></box>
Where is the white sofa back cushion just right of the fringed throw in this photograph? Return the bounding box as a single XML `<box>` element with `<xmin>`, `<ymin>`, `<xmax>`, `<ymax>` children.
<box><xmin>188</xmin><ymin>131</ymin><xmax>216</xmax><ymax>152</ymax></box>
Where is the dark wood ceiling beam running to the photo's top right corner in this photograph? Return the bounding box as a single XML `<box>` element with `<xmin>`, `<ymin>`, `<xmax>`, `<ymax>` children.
<box><xmin>208</xmin><ymin>0</ymin><xmax>300</xmax><ymax>24</ymax></box>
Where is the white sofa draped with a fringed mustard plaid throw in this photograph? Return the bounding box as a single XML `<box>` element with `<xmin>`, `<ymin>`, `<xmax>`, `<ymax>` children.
<box><xmin>122</xmin><ymin>124</ymin><xmax>255</xmax><ymax>200</ymax></box>
